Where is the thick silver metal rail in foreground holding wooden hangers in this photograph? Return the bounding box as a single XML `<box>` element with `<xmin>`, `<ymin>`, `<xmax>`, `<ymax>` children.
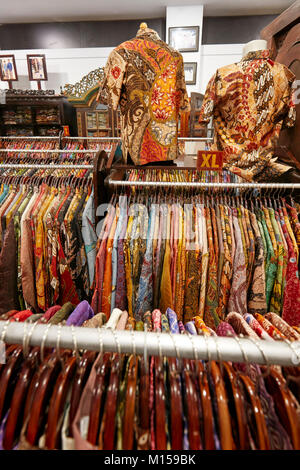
<box><xmin>0</xmin><ymin>321</ymin><xmax>300</xmax><ymax>366</ymax></box>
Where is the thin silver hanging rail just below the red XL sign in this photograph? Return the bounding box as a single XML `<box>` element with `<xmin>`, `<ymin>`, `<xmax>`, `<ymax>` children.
<box><xmin>108</xmin><ymin>178</ymin><xmax>300</xmax><ymax>189</ymax></box>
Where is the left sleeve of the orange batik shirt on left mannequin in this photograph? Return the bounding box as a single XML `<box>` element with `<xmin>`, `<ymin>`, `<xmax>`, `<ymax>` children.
<box><xmin>97</xmin><ymin>49</ymin><xmax>127</xmax><ymax>110</ymax></box>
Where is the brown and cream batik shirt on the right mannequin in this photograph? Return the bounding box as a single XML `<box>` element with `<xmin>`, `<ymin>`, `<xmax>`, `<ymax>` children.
<box><xmin>199</xmin><ymin>50</ymin><xmax>296</xmax><ymax>181</ymax></box>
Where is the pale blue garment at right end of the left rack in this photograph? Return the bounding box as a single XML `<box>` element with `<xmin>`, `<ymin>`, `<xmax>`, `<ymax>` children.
<box><xmin>81</xmin><ymin>190</ymin><xmax>97</xmax><ymax>287</ymax></box>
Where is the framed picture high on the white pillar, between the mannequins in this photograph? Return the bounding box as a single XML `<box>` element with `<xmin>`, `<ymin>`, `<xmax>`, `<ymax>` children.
<box><xmin>169</xmin><ymin>26</ymin><xmax>199</xmax><ymax>52</ymax></box>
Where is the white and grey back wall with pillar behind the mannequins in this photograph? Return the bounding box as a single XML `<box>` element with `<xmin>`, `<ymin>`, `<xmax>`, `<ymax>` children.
<box><xmin>0</xmin><ymin>13</ymin><xmax>274</xmax><ymax>94</ymax></box>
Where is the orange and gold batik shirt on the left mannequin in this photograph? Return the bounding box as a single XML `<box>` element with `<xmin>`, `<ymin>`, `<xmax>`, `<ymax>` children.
<box><xmin>99</xmin><ymin>28</ymin><xmax>190</xmax><ymax>165</ymax></box>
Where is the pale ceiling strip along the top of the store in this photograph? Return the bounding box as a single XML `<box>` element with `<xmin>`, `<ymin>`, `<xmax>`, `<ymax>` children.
<box><xmin>0</xmin><ymin>0</ymin><xmax>294</xmax><ymax>24</ymax></box>
